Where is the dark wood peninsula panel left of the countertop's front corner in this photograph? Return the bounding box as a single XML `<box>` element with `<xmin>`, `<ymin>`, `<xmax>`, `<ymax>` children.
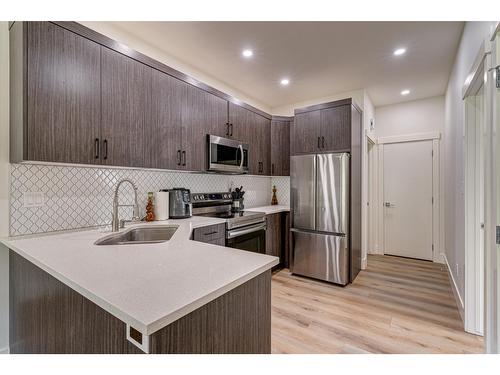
<box><xmin>9</xmin><ymin>250</ymin><xmax>142</xmax><ymax>354</ymax></box>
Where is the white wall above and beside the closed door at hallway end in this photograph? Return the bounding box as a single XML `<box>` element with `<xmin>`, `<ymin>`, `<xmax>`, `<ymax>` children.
<box><xmin>376</xmin><ymin>96</ymin><xmax>445</xmax><ymax>261</ymax></box>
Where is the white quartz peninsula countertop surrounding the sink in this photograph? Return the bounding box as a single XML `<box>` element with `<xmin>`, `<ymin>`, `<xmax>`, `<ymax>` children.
<box><xmin>0</xmin><ymin>217</ymin><xmax>278</xmax><ymax>335</ymax></box>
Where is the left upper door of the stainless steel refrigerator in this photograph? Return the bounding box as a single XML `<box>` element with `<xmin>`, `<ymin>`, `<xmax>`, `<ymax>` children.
<box><xmin>290</xmin><ymin>155</ymin><xmax>316</xmax><ymax>230</ymax></box>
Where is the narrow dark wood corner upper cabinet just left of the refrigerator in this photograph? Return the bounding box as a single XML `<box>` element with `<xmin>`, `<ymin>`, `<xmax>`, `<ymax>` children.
<box><xmin>271</xmin><ymin>117</ymin><xmax>291</xmax><ymax>176</ymax></box>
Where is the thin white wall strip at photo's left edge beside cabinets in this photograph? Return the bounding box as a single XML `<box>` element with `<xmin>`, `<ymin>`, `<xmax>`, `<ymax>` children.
<box><xmin>0</xmin><ymin>22</ymin><xmax>9</xmax><ymax>353</ymax></box>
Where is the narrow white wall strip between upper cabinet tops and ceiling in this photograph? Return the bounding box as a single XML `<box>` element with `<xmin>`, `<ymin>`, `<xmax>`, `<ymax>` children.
<box><xmin>78</xmin><ymin>21</ymin><xmax>271</xmax><ymax>113</ymax></box>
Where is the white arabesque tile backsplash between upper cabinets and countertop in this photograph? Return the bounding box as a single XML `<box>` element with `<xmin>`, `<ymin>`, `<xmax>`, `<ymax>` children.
<box><xmin>10</xmin><ymin>164</ymin><xmax>290</xmax><ymax>236</ymax></box>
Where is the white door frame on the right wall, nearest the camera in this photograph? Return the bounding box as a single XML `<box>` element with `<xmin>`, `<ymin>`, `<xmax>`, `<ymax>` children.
<box><xmin>462</xmin><ymin>42</ymin><xmax>487</xmax><ymax>336</ymax></box>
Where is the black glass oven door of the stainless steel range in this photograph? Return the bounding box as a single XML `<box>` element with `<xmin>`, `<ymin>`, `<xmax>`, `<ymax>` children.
<box><xmin>226</xmin><ymin>222</ymin><xmax>266</xmax><ymax>254</ymax></box>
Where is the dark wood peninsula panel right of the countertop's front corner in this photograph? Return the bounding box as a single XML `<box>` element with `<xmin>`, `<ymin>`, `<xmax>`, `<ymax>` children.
<box><xmin>150</xmin><ymin>270</ymin><xmax>271</xmax><ymax>354</ymax></box>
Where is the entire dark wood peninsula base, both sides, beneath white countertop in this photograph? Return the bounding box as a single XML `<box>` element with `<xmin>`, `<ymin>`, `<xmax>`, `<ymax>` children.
<box><xmin>9</xmin><ymin>251</ymin><xmax>271</xmax><ymax>354</ymax></box>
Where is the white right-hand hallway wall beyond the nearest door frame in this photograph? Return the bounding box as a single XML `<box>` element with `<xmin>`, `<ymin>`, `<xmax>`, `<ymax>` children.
<box><xmin>444</xmin><ymin>22</ymin><xmax>495</xmax><ymax>306</ymax></box>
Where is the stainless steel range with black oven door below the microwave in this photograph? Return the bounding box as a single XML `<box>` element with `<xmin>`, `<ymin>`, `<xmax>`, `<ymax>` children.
<box><xmin>191</xmin><ymin>193</ymin><xmax>267</xmax><ymax>254</ymax></box>
